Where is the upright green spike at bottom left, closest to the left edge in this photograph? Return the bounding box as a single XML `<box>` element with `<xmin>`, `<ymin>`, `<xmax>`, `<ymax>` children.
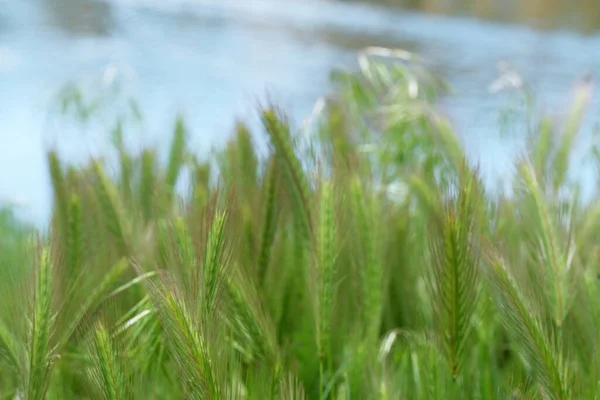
<box><xmin>27</xmin><ymin>248</ymin><xmax>53</xmax><ymax>400</ymax></box>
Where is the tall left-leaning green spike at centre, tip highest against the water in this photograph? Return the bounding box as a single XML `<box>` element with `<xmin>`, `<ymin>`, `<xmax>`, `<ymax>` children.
<box><xmin>262</xmin><ymin>109</ymin><xmax>312</xmax><ymax>240</ymax></box>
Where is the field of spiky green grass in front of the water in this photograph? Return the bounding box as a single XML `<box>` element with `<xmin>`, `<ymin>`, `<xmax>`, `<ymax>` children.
<box><xmin>0</xmin><ymin>48</ymin><xmax>600</xmax><ymax>400</ymax></box>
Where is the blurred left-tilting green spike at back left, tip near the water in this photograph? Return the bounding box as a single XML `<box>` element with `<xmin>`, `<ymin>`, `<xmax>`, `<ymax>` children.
<box><xmin>93</xmin><ymin>161</ymin><xmax>129</xmax><ymax>255</ymax></box>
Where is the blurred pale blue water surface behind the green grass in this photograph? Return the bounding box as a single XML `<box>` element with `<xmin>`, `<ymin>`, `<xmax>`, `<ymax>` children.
<box><xmin>0</xmin><ymin>0</ymin><xmax>600</xmax><ymax>225</ymax></box>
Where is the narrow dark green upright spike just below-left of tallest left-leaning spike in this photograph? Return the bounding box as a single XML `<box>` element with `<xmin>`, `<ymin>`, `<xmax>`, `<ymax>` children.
<box><xmin>258</xmin><ymin>158</ymin><xmax>280</xmax><ymax>285</ymax></box>
